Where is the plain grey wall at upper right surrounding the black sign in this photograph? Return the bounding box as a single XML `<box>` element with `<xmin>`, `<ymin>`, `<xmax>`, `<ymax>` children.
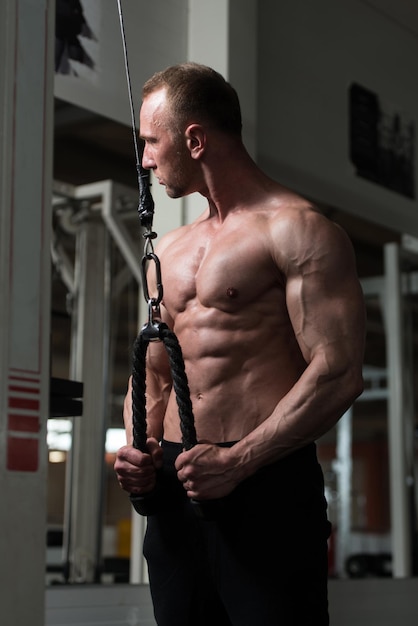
<box><xmin>258</xmin><ymin>0</ymin><xmax>418</xmax><ymax>236</ymax></box>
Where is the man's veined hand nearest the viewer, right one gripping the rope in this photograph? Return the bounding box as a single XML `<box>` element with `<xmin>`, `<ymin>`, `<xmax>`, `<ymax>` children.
<box><xmin>175</xmin><ymin>443</ymin><xmax>239</xmax><ymax>500</ymax></box>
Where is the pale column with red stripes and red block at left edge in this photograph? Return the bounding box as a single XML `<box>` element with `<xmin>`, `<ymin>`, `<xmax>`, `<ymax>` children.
<box><xmin>0</xmin><ymin>0</ymin><xmax>55</xmax><ymax>626</ymax></box>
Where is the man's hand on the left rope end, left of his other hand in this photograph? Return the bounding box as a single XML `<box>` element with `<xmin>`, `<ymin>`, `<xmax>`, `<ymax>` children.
<box><xmin>114</xmin><ymin>438</ymin><xmax>163</xmax><ymax>495</ymax></box>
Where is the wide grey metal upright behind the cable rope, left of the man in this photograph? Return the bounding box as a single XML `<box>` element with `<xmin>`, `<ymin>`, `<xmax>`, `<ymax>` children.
<box><xmin>69</xmin><ymin>207</ymin><xmax>110</xmax><ymax>583</ymax></box>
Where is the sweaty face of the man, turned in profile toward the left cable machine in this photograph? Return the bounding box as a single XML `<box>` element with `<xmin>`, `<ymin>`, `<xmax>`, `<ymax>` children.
<box><xmin>139</xmin><ymin>89</ymin><xmax>195</xmax><ymax>198</ymax></box>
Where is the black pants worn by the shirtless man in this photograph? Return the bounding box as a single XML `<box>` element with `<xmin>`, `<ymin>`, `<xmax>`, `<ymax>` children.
<box><xmin>144</xmin><ymin>442</ymin><xmax>330</xmax><ymax>626</ymax></box>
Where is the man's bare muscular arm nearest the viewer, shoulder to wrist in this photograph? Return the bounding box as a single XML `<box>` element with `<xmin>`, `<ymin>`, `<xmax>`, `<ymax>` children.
<box><xmin>231</xmin><ymin>212</ymin><xmax>365</xmax><ymax>477</ymax></box>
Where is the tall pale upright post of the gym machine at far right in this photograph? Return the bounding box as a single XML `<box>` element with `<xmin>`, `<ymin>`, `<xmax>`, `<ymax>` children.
<box><xmin>384</xmin><ymin>243</ymin><xmax>413</xmax><ymax>578</ymax></box>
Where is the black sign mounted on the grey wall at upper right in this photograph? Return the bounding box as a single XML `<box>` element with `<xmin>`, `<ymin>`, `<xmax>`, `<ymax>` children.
<box><xmin>349</xmin><ymin>83</ymin><xmax>415</xmax><ymax>198</ymax></box>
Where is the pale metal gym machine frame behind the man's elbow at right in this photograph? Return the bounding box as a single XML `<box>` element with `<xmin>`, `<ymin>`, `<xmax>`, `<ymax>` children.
<box><xmin>335</xmin><ymin>238</ymin><xmax>418</xmax><ymax>578</ymax></box>
